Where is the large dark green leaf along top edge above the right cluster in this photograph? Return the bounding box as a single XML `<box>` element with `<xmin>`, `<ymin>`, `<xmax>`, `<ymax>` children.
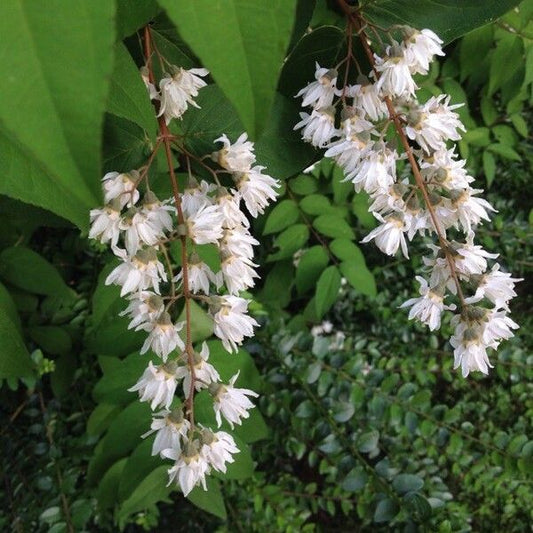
<box><xmin>363</xmin><ymin>0</ymin><xmax>520</xmax><ymax>43</ymax></box>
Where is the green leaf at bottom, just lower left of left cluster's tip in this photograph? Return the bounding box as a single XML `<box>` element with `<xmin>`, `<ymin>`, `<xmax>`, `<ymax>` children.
<box><xmin>118</xmin><ymin>465</ymin><xmax>172</xmax><ymax>529</ymax></box>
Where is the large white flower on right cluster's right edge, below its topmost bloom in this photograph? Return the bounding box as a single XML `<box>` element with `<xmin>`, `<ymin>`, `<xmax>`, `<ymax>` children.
<box><xmin>405</xmin><ymin>94</ymin><xmax>466</xmax><ymax>153</ymax></box>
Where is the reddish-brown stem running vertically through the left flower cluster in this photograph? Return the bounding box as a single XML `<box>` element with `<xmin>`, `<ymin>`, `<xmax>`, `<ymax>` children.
<box><xmin>144</xmin><ymin>25</ymin><xmax>196</xmax><ymax>431</ymax></box>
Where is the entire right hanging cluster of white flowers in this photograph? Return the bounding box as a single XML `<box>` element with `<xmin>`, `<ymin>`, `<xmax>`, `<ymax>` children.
<box><xmin>295</xmin><ymin>27</ymin><xmax>520</xmax><ymax>377</ymax></box>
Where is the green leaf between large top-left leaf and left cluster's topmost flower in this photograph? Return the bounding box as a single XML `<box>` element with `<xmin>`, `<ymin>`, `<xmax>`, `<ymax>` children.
<box><xmin>106</xmin><ymin>43</ymin><xmax>157</xmax><ymax>139</ymax></box>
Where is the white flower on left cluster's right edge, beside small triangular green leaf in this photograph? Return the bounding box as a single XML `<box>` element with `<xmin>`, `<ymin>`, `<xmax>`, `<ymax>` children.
<box><xmin>211</xmin><ymin>295</ymin><xmax>259</xmax><ymax>352</ymax></box>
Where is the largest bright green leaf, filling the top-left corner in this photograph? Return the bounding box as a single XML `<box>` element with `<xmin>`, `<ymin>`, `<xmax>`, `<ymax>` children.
<box><xmin>0</xmin><ymin>0</ymin><xmax>114</xmax><ymax>229</ymax></box>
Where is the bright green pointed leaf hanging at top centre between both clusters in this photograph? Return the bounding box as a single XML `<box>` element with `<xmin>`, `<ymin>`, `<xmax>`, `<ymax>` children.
<box><xmin>160</xmin><ymin>0</ymin><xmax>296</xmax><ymax>138</ymax></box>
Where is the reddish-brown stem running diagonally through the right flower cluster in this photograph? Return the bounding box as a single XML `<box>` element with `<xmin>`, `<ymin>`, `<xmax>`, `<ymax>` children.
<box><xmin>337</xmin><ymin>0</ymin><xmax>466</xmax><ymax>306</ymax></box>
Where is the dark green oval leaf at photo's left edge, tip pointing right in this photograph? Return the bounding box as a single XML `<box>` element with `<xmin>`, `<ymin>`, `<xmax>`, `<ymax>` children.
<box><xmin>0</xmin><ymin>246</ymin><xmax>74</xmax><ymax>299</ymax></box>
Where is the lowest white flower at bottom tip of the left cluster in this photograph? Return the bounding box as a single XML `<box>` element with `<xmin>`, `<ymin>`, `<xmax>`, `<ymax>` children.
<box><xmin>162</xmin><ymin>441</ymin><xmax>210</xmax><ymax>496</ymax></box>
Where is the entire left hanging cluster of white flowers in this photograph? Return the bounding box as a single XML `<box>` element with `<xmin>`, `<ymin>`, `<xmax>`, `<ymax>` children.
<box><xmin>89</xmin><ymin>53</ymin><xmax>279</xmax><ymax>495</ymax></box>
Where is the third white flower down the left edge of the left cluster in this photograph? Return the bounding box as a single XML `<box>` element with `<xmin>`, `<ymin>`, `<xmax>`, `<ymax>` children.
<box><xmin>105</xmin><ymin>248</ymin><xmax>167</xmax><ymax>296</ymax></box>
